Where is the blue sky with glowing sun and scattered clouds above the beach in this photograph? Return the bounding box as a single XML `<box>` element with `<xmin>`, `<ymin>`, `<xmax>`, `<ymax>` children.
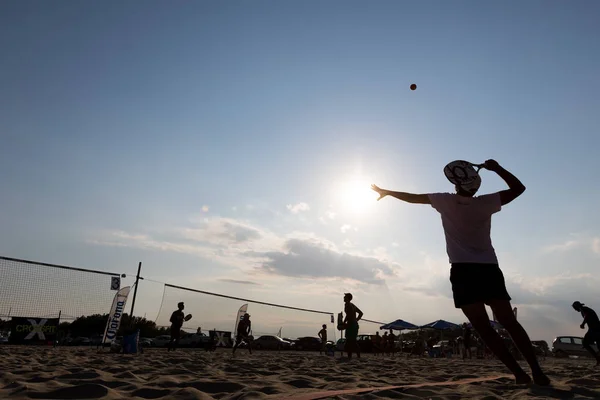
<box><xmin>0</xmin><ymin>0</ymin><xmax>600</xmax><ymax>341</ymax></box>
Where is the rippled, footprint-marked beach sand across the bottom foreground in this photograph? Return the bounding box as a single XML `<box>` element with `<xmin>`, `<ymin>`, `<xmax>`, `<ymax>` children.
<box><xmin>0</xmin><ymin>346</ymin><xmax>600</xmax><ymax>399</ymax></box>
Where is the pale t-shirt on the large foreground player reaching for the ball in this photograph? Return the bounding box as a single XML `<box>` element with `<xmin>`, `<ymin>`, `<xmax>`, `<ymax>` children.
<box><xmin>428</xmin><ymin>193</ymin><xmax>502</xmax><ymax>264</ymax></box>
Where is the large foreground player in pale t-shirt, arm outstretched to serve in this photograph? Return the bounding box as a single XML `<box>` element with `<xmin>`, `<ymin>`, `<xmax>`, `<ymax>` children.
<box><xmin>371</xmin><ymin>160</ymin><xmax>550</xmax><ymax>385</ymax></box>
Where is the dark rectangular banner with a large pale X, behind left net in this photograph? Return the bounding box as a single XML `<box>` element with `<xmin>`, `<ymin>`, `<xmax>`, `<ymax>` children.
<box><xmin>10</xmin><ymin>317</ymin><xmax>59</xmax><ymax>344</ymax></box>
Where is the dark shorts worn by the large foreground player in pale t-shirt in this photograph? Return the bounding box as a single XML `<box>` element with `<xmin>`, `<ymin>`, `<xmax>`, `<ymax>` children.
<box><xmin>450</xmin><ymin>263</ymin><xmax>511</xmax><ymax>308</ymax></box>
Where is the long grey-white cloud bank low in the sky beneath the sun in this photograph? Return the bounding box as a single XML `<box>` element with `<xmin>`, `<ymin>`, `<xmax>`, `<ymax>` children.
<box><xmin>90</xmin><ymin>217</ymin><xmax>397</xmax><ymax>284</ymax></box>
